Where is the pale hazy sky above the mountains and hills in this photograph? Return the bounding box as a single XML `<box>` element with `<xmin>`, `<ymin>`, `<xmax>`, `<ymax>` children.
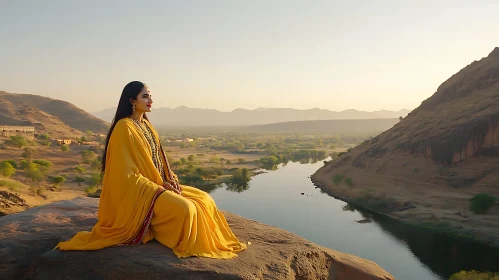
<box><xmin>0</xmin><ymin>0</ymin><xmax>499</xmax><ymax>111</ymax></box>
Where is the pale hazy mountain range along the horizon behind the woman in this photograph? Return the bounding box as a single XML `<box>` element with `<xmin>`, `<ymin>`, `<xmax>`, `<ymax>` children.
<box><xmin>93</xmin><ymin>106</ymin><xmax>410</xmax><ymax>126</ymax></box>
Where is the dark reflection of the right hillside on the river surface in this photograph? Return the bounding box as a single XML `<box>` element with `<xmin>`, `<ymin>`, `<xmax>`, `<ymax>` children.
<box><xmin>342</xmin><ymin>203</ymin><xmax>499</xmax><ymax>279</ymax></box>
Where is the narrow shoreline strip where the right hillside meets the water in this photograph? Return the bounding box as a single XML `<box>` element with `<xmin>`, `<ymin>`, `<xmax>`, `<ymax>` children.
<box><xmin>310</xmin><ymin>173</ymin><xmax>499</xmax><ymax>249</ymax></box>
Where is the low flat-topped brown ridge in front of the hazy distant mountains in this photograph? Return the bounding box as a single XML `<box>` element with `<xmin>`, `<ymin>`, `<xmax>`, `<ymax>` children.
<box><xmin>242</xmin><ymin>119</ymin><xmax>399</xmax><ymax>133</ymax></box>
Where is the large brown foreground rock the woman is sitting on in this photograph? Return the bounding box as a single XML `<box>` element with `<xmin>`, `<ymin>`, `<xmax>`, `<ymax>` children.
<box><xmin>0</xmin><ymin>198</ymin><xmax>394</xmax><ymax>280</ymax></box>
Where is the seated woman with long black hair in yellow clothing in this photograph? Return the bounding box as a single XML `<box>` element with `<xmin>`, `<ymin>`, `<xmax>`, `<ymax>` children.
<box><xmin>56</xmin><ymin>81</ymin><xmax>246</xmax><ymax>259</ymax></box>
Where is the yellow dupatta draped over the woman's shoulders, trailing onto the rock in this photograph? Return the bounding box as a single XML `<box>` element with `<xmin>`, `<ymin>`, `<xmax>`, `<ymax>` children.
<box><xmin>56</xmin><ymin>118</ymin><xmax>170</xmax><ymax>250</ymax></box>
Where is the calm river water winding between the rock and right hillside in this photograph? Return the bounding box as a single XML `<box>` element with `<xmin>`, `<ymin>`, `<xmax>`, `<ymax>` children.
<box><xmin>206</xmin><ymin>161</ymin><xmax>499</xmax><ymax>280</ymax></box>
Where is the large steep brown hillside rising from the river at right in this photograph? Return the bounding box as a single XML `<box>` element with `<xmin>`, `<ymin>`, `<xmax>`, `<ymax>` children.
<box><xmin>312</xmin><ymin>48</ymin><xmax>499</xmax><ymax>245</ymax></box>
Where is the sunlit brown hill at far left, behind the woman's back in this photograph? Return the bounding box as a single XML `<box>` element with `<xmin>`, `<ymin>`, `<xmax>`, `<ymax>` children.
<box><xmin>0</xmin><ymin>91</ymin><xmax>109</xmax><ymax>137</ymax></box>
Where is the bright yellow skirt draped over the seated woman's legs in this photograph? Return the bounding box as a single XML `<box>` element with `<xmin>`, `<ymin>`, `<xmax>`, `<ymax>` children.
<box><xmin>142</xmin><ymin>186</ymin><xmax>246</xmax><ymax>259</ymax></box>
